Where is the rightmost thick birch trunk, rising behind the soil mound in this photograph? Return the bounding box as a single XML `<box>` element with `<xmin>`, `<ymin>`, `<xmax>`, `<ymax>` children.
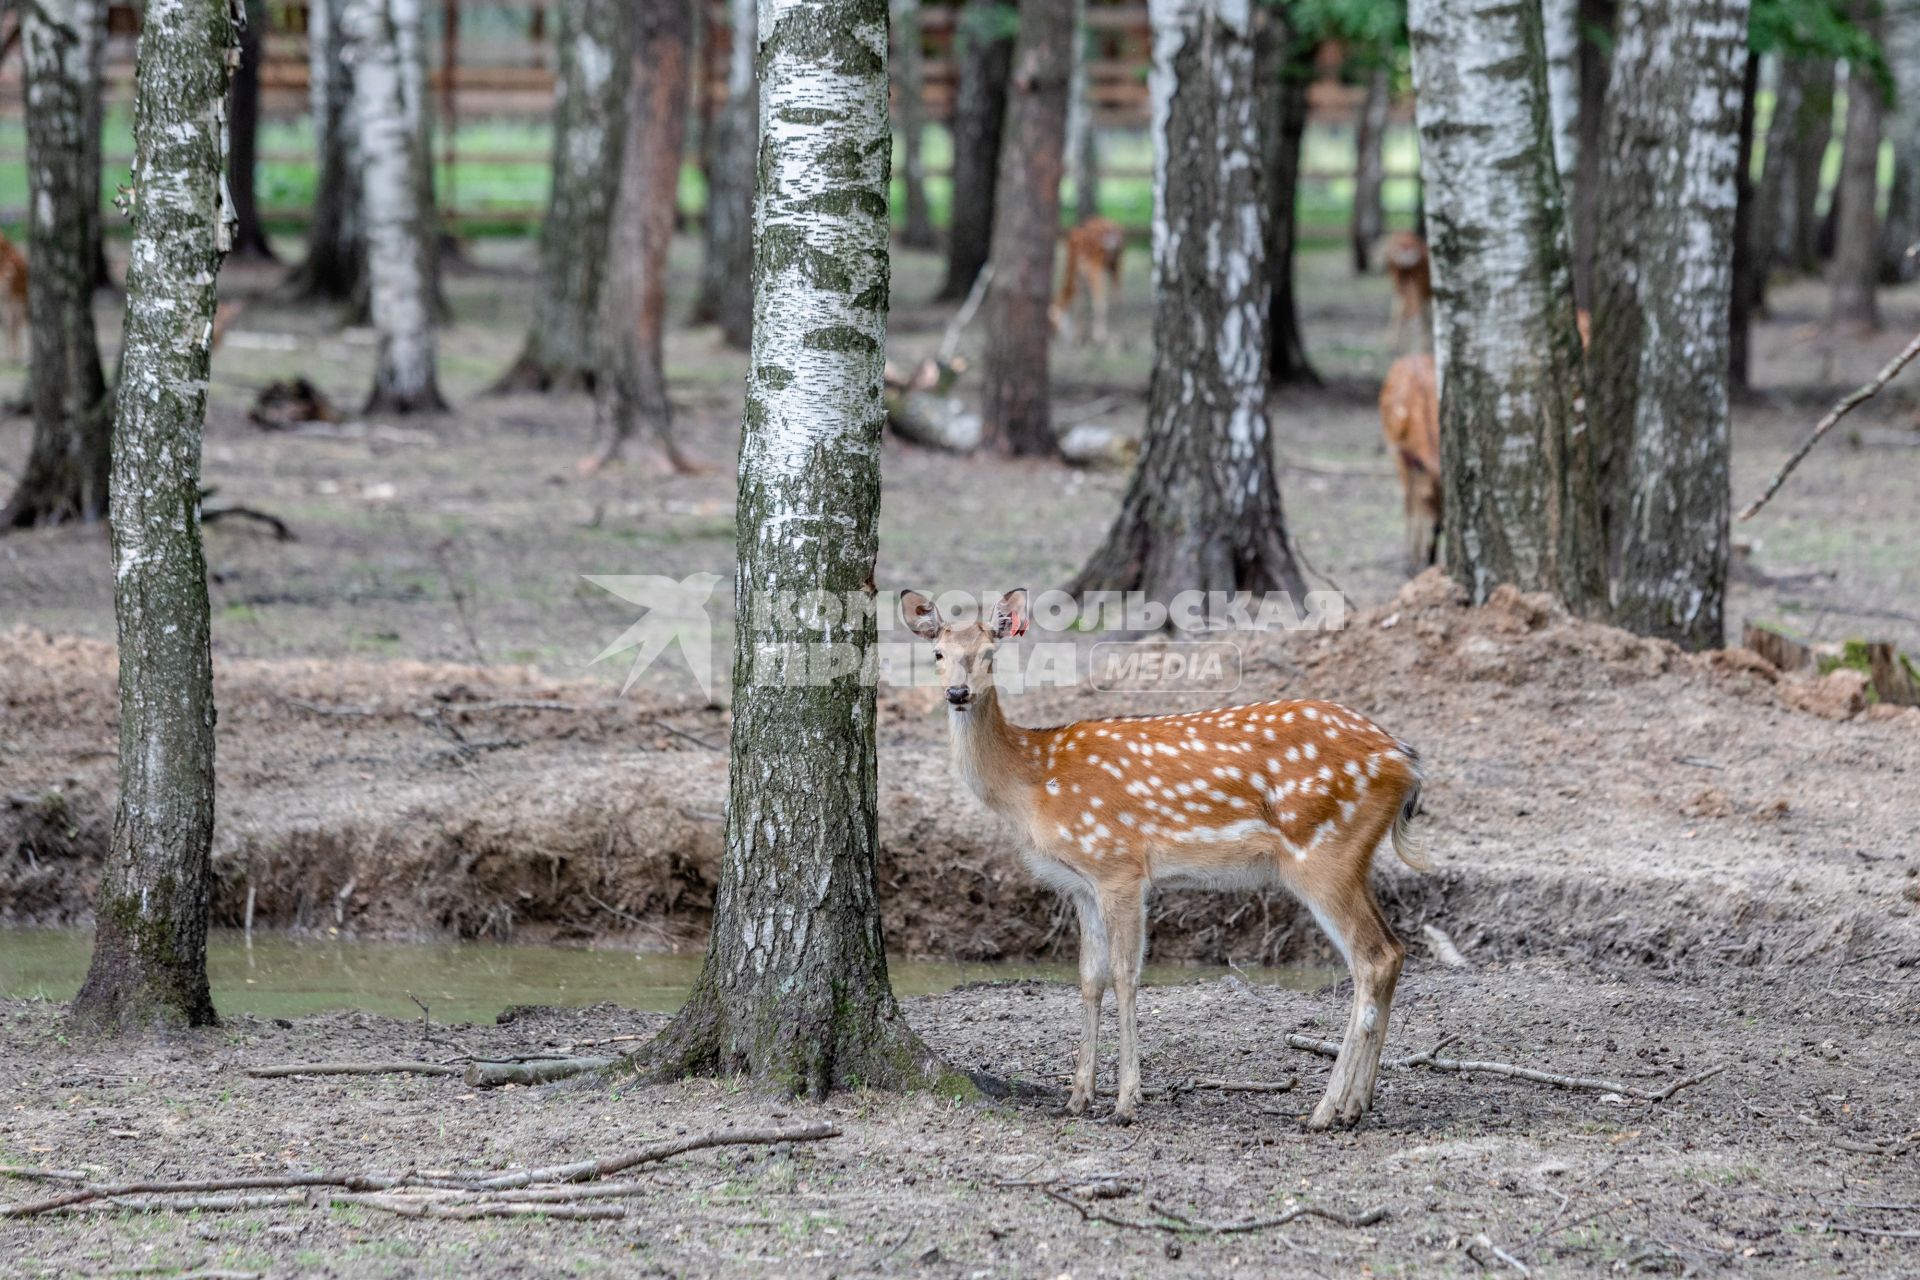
<box><xmin>1588</xmin><ymin>0</ymin><xmax>1747</xmax><ymax>649</ymax></box>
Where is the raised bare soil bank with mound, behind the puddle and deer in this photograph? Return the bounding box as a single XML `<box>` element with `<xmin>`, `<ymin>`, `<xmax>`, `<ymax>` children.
<box><xmin>0</xmin><ymin>574</ymin><xmax>1920</xmax><ymax>969</ymax></box>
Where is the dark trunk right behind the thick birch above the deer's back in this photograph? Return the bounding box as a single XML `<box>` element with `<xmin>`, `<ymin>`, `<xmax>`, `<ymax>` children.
<box><xmin>1254</xmin><ymin>10</ymin><xmax>1321</xmax><ymax>388</ymax></box>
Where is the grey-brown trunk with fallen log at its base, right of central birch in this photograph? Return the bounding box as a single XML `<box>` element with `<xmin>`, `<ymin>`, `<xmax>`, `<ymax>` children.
<box><xmin>981</xmin><ymin>0</ymin><xmax>1075</xmax><ymax>457</ymax></box>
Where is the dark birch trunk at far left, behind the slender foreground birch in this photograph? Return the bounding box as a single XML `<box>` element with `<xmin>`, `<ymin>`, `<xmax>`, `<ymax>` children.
<box><xmin>0</xmin><ymin>0</ymin><xmax>113</xmax><ymax>530</ymax></box>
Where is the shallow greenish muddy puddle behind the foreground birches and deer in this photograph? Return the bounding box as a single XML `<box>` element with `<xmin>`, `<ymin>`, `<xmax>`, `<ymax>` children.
<box><xmin>0</xmin><ymin>929</ymin><xmax>1340</xmax><ymax>1023</ymax></box>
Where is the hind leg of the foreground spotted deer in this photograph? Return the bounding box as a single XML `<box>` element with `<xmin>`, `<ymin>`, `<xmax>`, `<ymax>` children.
<box><xmin>1308</xmin><ymin>809</ymin><xmax>1407</xmax><ymax>1128</ymax></box>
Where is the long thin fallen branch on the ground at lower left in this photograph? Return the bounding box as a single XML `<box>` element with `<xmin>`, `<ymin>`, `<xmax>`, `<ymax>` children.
<box><xmin>0</xmin><ymin>1125</ymin><xmax>839</xmax><ymax>1219</ymax></box>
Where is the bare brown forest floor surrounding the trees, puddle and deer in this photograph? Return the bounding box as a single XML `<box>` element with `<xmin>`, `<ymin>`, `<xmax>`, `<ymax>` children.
<box><xmin>0</xmin><ymin>244</ymin><xmax>1920</xmax><ymax>1276</ymax></box>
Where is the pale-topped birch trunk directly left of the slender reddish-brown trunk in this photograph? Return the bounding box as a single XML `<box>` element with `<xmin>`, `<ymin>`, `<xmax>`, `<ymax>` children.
<box><xmin>495</xmin><ymin>0</ymin><xmax>634</xmax><ymax>391</ymax></box>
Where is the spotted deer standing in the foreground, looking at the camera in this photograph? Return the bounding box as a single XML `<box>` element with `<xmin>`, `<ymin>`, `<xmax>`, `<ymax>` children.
<box><xmin>900</xmin><ymin>591</ymin><xmax>1427</xmax><ymax>1128</ymax></box>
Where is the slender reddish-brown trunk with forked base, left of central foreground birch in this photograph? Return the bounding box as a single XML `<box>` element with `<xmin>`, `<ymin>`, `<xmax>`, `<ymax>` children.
<box><xmin>593</xmin><ymin>0</ymin><xmax>693</xmax><ymax>472</ymax></box>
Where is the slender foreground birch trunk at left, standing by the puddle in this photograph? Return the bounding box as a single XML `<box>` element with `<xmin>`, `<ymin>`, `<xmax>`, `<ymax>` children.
<box><xmin>73</xmin><ymin>0</ymin><xmax>240</xmax><ymax>1031</ymax></box>
